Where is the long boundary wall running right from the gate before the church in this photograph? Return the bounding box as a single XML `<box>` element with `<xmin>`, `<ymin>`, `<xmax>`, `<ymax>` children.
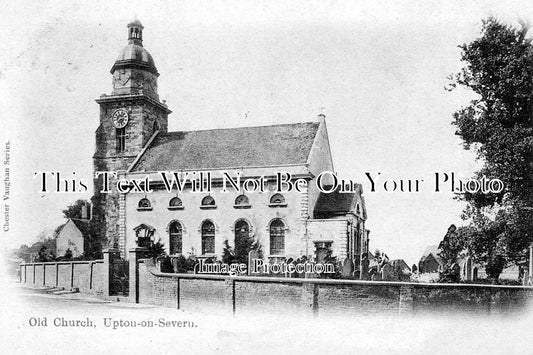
<box><xmin>136</xmin><ymin>260</ymin><xmax>533</xmax><ymax>316</ymax></box>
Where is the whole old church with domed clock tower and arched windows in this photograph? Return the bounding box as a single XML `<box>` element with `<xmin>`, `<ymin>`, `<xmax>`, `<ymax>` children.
<box><xmin>93</xmin><ymin>20</ymin><xmax>369</xmax><ymax>265</ymax></box>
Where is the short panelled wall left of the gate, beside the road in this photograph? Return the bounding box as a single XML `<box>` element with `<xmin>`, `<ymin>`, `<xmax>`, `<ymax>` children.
<box><xmin>20</xmin><ymin>260</ymin><xmax>105</xmax><ymax>295</ymax></box>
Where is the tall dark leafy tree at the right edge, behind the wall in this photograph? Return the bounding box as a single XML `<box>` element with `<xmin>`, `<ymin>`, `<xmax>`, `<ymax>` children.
<box><xmin>452</xmin><ymin>17</ymin><xmax>533</xmax><ymax>278</ymax></box>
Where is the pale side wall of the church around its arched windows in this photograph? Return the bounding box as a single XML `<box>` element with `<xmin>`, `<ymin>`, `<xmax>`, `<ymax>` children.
<box><xmin>124</xmin><ymin>181</ymin><xmax>312</xmax><ymax>257</ymax></box>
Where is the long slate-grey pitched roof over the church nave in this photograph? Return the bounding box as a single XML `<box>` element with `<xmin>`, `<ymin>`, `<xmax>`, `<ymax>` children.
<box><xmin>132</xmin><ymin>122</ymin><xmax>319</xmax><ymax>171</ymax></box>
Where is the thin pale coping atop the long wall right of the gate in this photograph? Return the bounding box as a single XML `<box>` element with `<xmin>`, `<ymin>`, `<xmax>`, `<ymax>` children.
<box><xmin>139</xmin><ymin>259</ymin><xmax>533</xmax><ymax>292</ymax></box>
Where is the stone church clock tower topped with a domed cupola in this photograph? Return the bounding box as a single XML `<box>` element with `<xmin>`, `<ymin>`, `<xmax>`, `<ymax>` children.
<box><xmin>93</xmin><ymin>19</ymin><xmax>171</xmax><ymax>252</ymax></box>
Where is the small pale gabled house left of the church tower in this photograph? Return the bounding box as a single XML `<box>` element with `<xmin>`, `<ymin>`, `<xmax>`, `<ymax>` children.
<box><xmin>56</xmin><ymin>218</ymin><xmax>89</xmax><ymax>257</ymax></box>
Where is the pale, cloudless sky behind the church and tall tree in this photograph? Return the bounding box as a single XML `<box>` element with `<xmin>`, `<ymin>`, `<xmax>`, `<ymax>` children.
<box><xmin>0</xmin><ymin>0</ymin><xmax>533</xmax><ymax>264</ymax></box>
